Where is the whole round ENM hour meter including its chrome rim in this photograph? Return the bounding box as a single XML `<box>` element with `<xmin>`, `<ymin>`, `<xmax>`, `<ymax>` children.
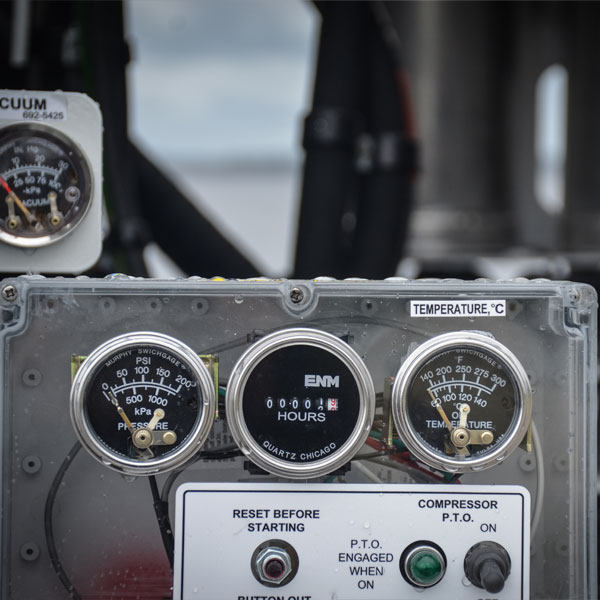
<box><xmin>226</xmin><ymin>329</ymin><xmax>375</xmax><ymax>479</ymax></box>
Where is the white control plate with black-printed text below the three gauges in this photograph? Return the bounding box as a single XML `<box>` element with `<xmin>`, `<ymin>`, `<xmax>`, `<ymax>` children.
<box><xmin>173</xmin><ymin>483</ymin><xmax>530</xmax><ymax>600</ymax></box>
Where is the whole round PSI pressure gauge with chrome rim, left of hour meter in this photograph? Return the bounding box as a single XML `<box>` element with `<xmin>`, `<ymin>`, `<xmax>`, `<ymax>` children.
<box><xmin>71</xmin><ymin>332</ymin><xmax>215</xmax><ymax>475</ymax></box>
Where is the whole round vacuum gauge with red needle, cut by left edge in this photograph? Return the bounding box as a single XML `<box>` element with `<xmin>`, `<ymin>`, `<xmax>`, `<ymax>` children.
<box><xmin>0</xmin><ymin>123</ymin><xmax>92</xmax><ymax>248</ymax></box>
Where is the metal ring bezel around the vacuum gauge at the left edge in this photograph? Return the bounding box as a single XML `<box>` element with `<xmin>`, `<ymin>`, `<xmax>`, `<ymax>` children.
<box><xmin>0</xmin><ymin>122</ymin><xmax>94</xmax><ymax>249</ymax></box>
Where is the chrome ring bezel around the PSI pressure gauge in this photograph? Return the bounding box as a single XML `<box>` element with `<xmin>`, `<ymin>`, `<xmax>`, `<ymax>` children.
<box><xmin>70</xmin><ymin>331</ymin><xmax>216</xmax><ymax>475</ymax></box>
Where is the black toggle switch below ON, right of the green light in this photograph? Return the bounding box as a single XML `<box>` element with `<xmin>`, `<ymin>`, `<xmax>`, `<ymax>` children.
<box><xmin>465</xmin><ymin>542</ymin><xmax>510</xmax><ymax>594</ymax></box>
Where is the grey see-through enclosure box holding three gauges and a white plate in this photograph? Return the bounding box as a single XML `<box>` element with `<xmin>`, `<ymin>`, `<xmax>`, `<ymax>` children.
<box><xmin>0</xmin><ymin>275</ymin><xmax>597</xmax><ymax>600</ymax></box>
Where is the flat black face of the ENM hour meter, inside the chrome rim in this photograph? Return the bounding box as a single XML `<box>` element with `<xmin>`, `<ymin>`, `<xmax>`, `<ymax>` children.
<box><xmin>242</xmin><ymin>344</ymin><xmax>360</xmax><ymax>463</ymax></box>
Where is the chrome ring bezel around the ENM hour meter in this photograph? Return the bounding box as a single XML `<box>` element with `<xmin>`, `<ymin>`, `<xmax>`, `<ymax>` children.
<box><xmin>225</xmin><ymin>328</ymin><xmax>375</xmax><ymax>479</ymax></box>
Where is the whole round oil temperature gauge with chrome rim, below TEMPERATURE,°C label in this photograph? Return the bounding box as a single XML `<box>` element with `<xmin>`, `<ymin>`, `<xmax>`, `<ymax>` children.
<box><xmin>392</xmin><ymin>331</ymin><xmax>532</xmax><ymax>472</ymax></box>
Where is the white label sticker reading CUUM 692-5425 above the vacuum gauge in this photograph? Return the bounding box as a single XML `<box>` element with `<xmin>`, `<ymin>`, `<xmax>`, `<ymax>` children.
<box><xmin>0</xmin><ymin>90</ymin><xmax>67</xmax><ymax>121</ymax></box>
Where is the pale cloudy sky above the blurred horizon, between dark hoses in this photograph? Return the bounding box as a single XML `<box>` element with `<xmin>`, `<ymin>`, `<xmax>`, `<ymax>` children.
<box><xmin>126</xmin><ymin>0</ymin><xmax>318</xmax><ymax>161</ymax></box>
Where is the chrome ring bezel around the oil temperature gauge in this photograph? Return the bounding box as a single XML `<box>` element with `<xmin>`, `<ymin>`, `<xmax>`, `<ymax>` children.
<box><xmin>392</xmin><ymin>331</ymin><xmax>533</xmax><ymax>473</ymax></box>
